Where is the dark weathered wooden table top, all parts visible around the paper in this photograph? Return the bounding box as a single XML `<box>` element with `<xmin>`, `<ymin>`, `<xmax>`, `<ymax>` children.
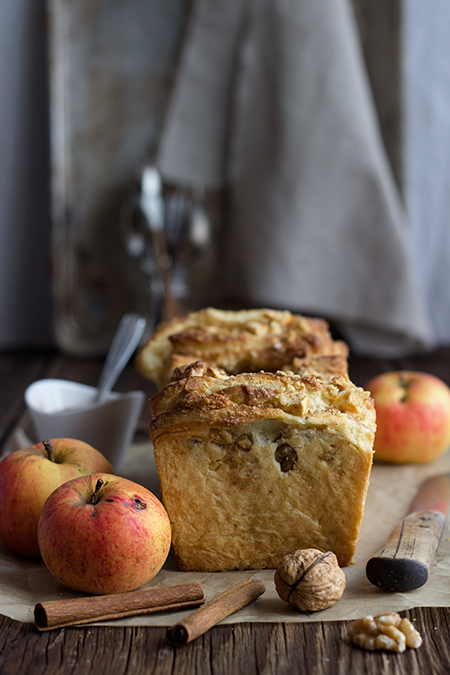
<box><xmin>0</xmin><ymin>348</ymin><xmax>450</xmax><ymax>675</ymax></box>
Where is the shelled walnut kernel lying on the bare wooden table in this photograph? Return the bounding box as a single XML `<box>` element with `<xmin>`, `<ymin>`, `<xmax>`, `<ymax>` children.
<box><xmin>348</xmin><ymin>612</ymin><xmax>422</xmax><ymax>652</ymax></box>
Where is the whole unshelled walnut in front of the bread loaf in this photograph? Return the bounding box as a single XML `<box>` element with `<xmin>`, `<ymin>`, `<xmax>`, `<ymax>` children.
<box><xmin>275</xmin><ymin>548</ymin><xmax>345</xmax><ymax>612</ymax></box>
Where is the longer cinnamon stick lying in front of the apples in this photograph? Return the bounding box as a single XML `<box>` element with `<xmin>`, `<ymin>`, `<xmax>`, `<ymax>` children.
<box><xmin>34</xmin><ymin>582</ymin><xmax>205</xmax><ymax>631</ymax></box>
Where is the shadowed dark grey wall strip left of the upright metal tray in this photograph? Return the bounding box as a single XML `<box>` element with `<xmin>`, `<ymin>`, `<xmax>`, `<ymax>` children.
<box><xmin>0</xmin><ymin>0</ymin><xmax>52</xmax><ymax>348</ymax></box>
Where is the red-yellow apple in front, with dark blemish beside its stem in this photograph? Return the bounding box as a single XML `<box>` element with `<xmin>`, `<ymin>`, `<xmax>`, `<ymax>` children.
<box><xmin>38</xmin><ymin>473</ymin><xmax>171</xmax><ymax>595</ymax></box>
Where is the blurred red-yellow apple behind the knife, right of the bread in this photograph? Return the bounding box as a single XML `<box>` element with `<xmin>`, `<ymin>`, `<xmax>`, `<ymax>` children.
<box><xmin>366</xmin><ymin>370</ymin><xmax>450</xmax><ymax>463</ymax></box>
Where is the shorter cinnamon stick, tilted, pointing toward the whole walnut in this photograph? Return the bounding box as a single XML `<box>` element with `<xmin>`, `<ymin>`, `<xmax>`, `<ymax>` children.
<box><xmin>167</xmin><ymin>577</ymin><xmax>266</xmax><ymax>645</ymax></box>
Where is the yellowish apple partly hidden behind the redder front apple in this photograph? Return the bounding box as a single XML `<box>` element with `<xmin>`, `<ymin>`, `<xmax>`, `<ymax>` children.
<box><xmin>0</xmin><ymin>438</ymin><xmax>113</xmax><ymax>558</ymax></box>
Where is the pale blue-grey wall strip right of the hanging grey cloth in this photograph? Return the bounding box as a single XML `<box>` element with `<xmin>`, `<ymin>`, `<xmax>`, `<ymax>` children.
<box><xmin>402</xmin><ymin>0</ymin><xmax>450</xmax><ymax>344</ymax></box>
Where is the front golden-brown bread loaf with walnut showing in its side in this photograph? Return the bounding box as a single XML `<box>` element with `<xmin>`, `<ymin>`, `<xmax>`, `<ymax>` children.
<box><xmin>150</xmin><ymin>362</ymin><xmax>375</xmax><ymax>572</ymax></box>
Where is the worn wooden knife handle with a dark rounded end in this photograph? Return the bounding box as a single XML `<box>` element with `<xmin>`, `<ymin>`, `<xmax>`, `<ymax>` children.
<box><xmin>366</xmin><ymin>511</ymin><xmax>445</xmax><ymax>593</ymax></box>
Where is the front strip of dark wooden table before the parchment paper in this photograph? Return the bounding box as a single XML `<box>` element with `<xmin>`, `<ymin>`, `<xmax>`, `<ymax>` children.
<box><xmin>0</xmin><ymin>608</ymin><xmax>450</xmax><ymax>675</ymax></box>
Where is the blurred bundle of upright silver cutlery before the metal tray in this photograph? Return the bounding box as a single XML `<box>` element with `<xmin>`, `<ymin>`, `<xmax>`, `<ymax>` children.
<box><xmin>121</xmin><ymin>165</ymin><xmax>211</xmax><ymax>331</ymax></box>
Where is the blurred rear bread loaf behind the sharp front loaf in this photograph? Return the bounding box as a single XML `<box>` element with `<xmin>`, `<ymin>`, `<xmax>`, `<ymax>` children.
<box><xmin>136</xmin><ymin>308</ymin><xmax>348</xmax><ymax>389</ymax></box>
